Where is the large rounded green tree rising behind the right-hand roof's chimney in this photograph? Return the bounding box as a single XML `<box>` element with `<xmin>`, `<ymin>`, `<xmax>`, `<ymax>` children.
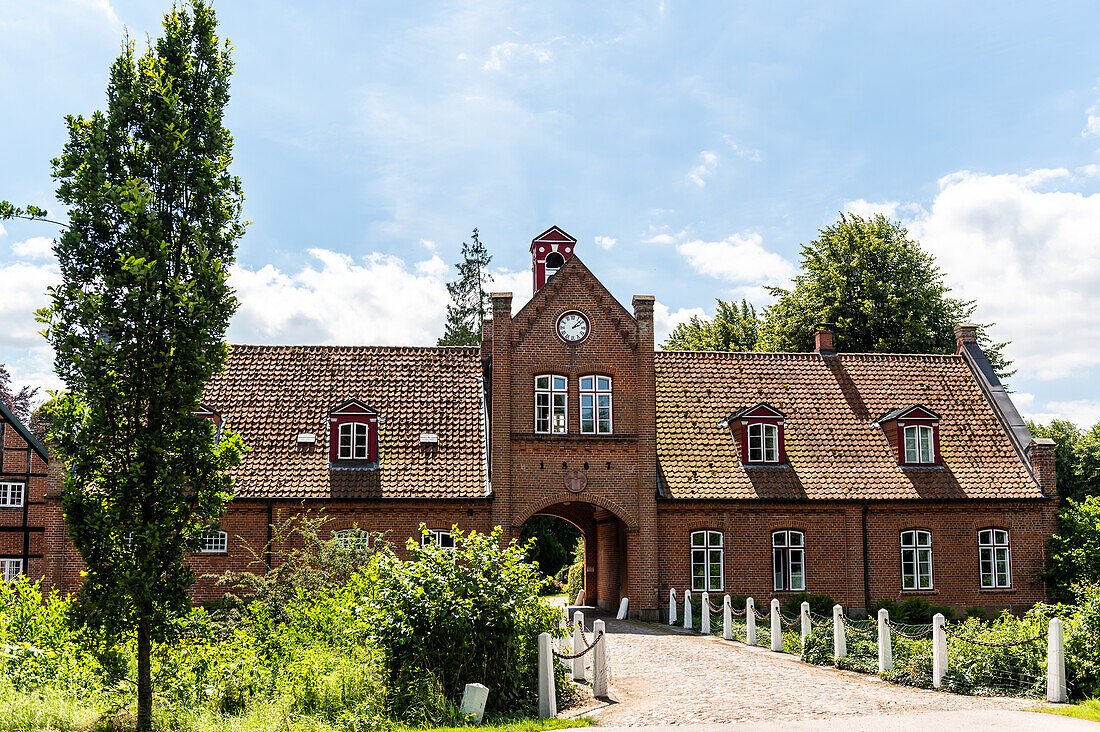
<box><xmin>758</xmin><ymin>214</ymin><xmax>1013</xmax><ymax>376</ymax></box>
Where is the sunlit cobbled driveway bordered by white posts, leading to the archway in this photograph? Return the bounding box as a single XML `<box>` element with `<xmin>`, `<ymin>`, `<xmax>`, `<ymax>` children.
<box><xmin>567</xmin><ymin>618</ymin><xmax>1100</xmax><ymax>732</ymax></box>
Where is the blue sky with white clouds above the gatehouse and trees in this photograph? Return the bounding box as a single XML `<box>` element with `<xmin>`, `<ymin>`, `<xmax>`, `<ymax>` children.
<box><xmin>0</xmin><ymin>0</ymin><xmax>1100</xmax><ymax>424</ymax></box>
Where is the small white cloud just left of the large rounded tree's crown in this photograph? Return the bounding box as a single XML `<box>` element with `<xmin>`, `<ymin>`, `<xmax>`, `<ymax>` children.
<box><xmin>677</xmin><ymin>231</ymin><xmax>794</xmax><ymax>286</ymax></box>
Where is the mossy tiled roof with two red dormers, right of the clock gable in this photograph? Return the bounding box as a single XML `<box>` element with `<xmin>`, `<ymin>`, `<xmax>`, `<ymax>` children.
<box><xmin>655</xmin><ymin>351</ymin><xmax>1043</xmax><ymax>499</ymax></box>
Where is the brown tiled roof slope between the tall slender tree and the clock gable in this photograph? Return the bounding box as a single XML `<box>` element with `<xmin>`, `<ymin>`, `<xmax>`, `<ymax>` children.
<box><xmin>202</xmin><ymin>346</ymin><xmax>485</xmax><ymax>498</ymax></box>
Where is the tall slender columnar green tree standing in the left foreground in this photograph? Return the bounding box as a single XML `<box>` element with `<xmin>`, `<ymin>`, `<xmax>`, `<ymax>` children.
<box><xmin>7</xmin><ymin>0</ymin><xmax>243</xmax><ymax>730</ymax></box>
